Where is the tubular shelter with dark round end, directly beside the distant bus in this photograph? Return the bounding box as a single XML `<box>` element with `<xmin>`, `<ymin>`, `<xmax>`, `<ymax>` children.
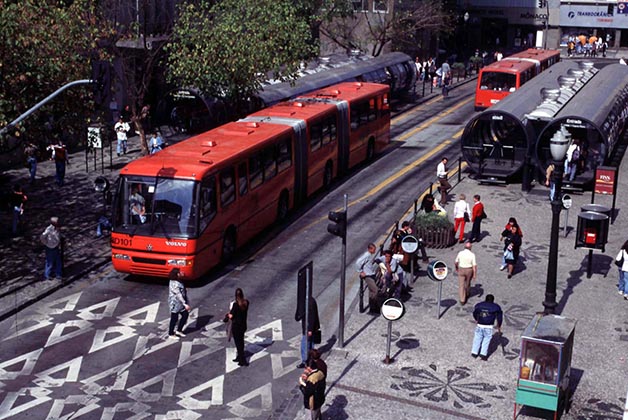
<box><xmin>461</xmin><ymin>61</ymin><xmax>594</xmax><ymax>180</ymax></box>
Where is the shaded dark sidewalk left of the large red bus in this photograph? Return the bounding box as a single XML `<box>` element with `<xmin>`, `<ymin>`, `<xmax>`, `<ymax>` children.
<box><xmin>0</xmin><ymin>137</ymin><xmax>140</xmax><ymax>320</ymax></box>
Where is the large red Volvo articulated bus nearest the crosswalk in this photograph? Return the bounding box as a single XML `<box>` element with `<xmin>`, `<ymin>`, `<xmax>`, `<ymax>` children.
<box><xmin>111</xmin><ymin>82</ymin><xmax>390</xmax><ymax>279</ymax></box>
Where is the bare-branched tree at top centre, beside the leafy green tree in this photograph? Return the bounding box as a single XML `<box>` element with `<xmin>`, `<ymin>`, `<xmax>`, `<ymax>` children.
<box><xmin>321</xmin><ymin>0</ymin><xmax>453</xmax><ymax>56</ymax></box>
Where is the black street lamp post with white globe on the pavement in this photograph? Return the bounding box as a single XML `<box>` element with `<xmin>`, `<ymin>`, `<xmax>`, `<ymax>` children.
<box><xmin>543</xmin><ymin>127</ymin><xmax>571</xmax><ymax>315</ymax></box>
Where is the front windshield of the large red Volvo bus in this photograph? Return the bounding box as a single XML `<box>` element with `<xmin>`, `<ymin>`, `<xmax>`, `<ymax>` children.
<box><xmin>113</xmin><ymin>176</ymin><xmax>197</xmax><ymax>239</ymax></box>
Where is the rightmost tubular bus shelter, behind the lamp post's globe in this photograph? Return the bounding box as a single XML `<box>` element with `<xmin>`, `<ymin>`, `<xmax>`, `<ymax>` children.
<box><xmin>535</xmin><ymin>64</ymin><xmax>628</xmax><ymax>189</ymax></box>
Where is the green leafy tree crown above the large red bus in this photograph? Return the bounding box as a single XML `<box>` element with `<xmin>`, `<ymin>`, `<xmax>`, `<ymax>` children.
<box><xmin>166</xmin><ymin>0</ymin><xmax>314</xmax><ymax>107</ymax></box>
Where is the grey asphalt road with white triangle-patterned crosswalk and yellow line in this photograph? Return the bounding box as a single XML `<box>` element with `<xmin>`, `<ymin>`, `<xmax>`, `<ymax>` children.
<box><xmin>0</xmin><ymin>83</ymin><xmax>474</xmax><ymax>419</ymax></box>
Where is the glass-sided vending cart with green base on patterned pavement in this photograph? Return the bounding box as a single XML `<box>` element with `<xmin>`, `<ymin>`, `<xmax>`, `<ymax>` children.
<box><xmin>514</xmin><ymin>313</ymin><xmax>576</xmax><ymax>420</ymax></box>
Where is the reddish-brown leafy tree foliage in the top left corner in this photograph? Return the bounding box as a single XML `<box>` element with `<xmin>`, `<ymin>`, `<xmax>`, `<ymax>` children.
<box><xmin>0</xmin><ymin>0</ymin><xmax>97</xmax><ymax>149</ymax></box>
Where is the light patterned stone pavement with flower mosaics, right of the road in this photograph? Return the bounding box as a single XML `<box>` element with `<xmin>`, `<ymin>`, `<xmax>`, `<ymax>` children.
<box><xmin>291</xmin><ymin>160</ymin><xmax>628</xmax><ymax>420</ymax></box>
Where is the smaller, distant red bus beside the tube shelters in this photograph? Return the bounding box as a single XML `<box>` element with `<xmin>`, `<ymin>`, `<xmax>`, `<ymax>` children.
<box><xmin>475</xmin><ymin>49</ymin><xmax>560</xmax><ymax>111</ymax></box>
